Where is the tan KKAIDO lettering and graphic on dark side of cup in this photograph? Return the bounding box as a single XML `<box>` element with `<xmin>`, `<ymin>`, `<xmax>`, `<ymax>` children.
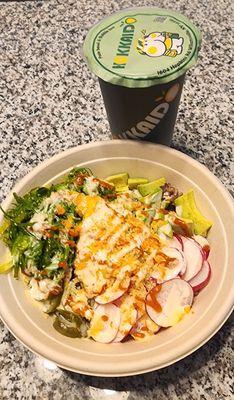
<box><xmin>117</xmin><ymin>83</ymin><xmax>180</xmax><ymax>139</ymax></box>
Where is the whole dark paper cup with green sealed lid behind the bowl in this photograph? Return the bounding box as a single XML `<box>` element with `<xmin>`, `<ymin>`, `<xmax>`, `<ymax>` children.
<box><xmin>84</xmin><ymin>7</ymin><xmax>201</xmax><ymax>145</ymax></box>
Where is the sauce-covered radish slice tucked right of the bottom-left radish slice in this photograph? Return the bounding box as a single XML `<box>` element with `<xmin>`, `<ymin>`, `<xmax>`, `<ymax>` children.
<box><xmin>113</xmin><ymin>296</ymin><xmax>137</xmax><ymax>343</ymax></box>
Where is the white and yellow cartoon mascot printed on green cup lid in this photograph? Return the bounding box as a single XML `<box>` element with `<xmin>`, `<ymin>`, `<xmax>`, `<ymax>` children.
<box><xmin>137</xmin><ymin>31</ymin><xmax>184</xmax><ymax>57</ymax></box>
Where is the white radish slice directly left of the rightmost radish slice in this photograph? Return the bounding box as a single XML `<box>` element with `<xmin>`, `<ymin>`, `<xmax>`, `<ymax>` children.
<box><xmin>182</xmin><ymin>237</ymin><xmax>204</xmax><ymax>281</ymax></box>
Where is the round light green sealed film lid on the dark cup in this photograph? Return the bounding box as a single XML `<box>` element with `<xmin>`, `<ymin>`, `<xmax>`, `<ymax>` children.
<box><xmin>84</xmin><ymin>7</ymin><xmax>201</xmax><ymax>88</ymax></box>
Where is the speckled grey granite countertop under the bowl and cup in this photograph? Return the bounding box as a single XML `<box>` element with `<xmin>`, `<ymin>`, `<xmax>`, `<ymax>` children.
<box><xmin>0</xmin><ymin>0</ymin><xmax>234</xmax><ymax>400</ymax></box>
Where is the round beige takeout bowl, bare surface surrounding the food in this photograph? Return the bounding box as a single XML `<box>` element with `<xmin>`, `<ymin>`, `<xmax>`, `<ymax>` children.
<box><xmin>0</xmin><ymin>140</ymin><xmax>234</xmax><ymax>376</ymax></box>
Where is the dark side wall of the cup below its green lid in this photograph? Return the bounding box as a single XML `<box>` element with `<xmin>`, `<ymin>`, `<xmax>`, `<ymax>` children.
<box><xmin>99</xmin><ymin>74</ymin><xmax>185</xmax><ymax>146</ymax></box>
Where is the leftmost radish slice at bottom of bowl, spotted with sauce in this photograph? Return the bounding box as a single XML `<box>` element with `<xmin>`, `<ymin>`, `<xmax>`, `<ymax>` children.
<box><xmin>89</xmin><ymin>304</ymin><xmax>120</xmax><ymax>343</ymax></box>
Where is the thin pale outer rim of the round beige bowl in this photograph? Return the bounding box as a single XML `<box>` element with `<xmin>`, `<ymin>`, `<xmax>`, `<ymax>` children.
<box><xmin>0</xmin><ymin>140</ymin><xmax>234</xmax><ymax>377</ymax></box>
